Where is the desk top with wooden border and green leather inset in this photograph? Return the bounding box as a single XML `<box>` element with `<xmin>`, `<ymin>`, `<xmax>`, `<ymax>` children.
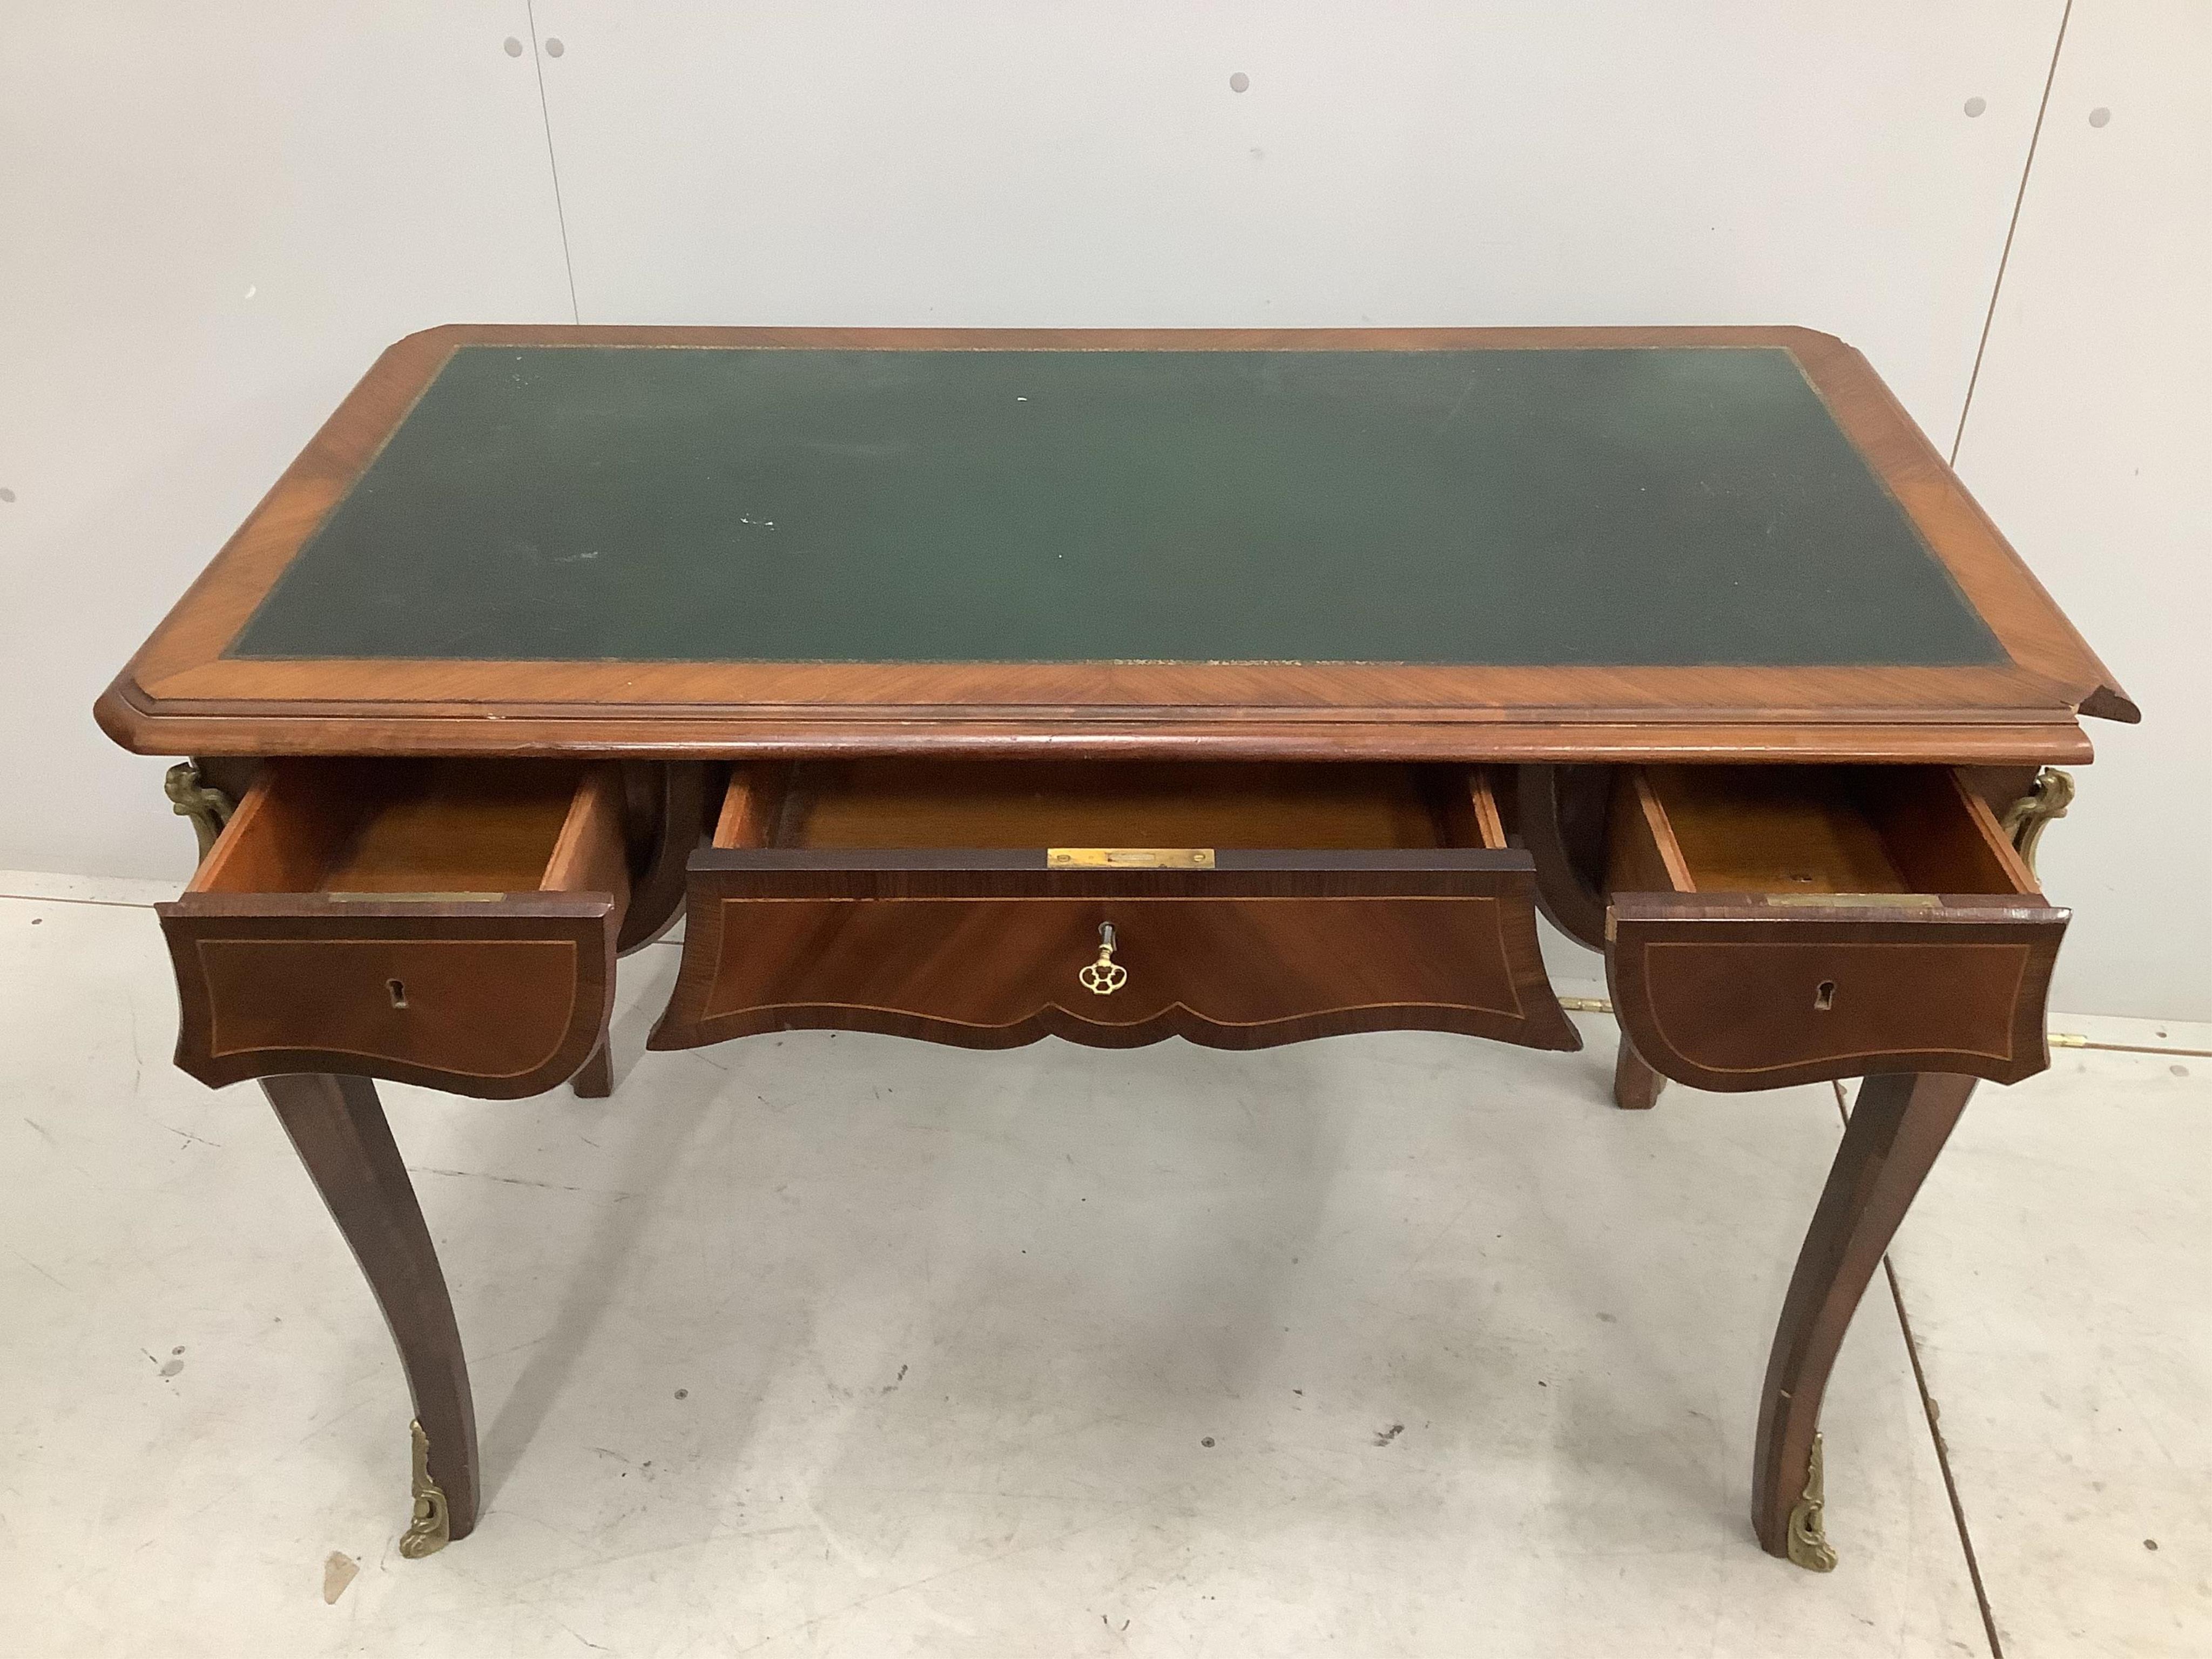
<box><xmin>97</xmin><ymin>327</ymin><xmax>2135</xmax><ymax>761</ymax></box>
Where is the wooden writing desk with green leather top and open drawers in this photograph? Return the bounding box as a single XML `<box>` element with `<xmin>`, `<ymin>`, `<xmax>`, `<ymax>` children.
<box><xmin>97</xmin><ymin>327</ymin><xmax>2137</xmax><ymax>1566</ymax></box>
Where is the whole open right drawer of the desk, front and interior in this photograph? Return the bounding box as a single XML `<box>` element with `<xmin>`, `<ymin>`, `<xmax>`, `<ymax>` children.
<box><xmin>1606</xmin><ymin>765</ymin><xmax>2066</xmax><ymax>1106</ymax></box>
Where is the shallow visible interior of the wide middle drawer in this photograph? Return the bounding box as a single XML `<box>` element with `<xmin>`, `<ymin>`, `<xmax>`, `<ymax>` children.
<box><xmin>714</xmin><ymin>759</ymin><xmax>1506</xmax><ymax>849</ymax></box>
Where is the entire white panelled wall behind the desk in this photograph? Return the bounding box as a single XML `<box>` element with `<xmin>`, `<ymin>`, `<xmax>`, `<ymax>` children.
<box><xmin>0</xmin><ymin>0</ymin><xmax>2212</xmax><ymax>1017</ymax></box>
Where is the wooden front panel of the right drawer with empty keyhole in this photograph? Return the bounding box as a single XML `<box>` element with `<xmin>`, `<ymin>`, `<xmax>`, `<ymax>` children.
<box><xmin>1606</xmin><ymin>894</ymin><xmax>2066</xmax><ymax>1090</ymax></box>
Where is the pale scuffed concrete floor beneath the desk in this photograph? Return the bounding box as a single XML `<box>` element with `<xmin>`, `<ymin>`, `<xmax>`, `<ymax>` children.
<box><xmin>0</xmin><ymin>878</ymin><xmax>2212</xmax><ymax>1659</ymax></box>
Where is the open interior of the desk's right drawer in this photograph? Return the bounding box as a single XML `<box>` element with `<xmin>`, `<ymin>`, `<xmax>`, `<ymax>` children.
<box><xmin>1608</xmin><ymin>765</ymin><xmax>2035</xmax><ymax>894</ymax></box>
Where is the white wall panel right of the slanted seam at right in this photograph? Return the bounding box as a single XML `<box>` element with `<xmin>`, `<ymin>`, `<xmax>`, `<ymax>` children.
<box><xmin>1958</xmin><ymin>0</ymin><xmax>2212</xmax><ymax>1017</ymax></box>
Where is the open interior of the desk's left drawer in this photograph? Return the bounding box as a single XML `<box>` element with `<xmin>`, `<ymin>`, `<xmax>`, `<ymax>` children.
<box><xmin>186</xmin><ymin>759</ymin><xmax>626</xmax><ymax>896</ymax></box>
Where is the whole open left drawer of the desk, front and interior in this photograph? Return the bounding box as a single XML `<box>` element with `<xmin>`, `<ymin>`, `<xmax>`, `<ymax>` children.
<box><xmin>159</xmin><ymin>759</ymin><xmax>630</xmax><ymax>1100</ymax></box>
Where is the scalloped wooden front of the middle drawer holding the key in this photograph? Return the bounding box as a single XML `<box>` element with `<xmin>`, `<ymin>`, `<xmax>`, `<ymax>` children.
<box><xmin>652</xmin><ymin>854</ymin><xmax>1577</xmax><ymax>1049</ymax></box>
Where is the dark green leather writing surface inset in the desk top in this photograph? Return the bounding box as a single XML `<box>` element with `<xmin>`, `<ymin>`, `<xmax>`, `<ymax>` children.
<box><xmin>224</xmin><ymin>345</ymin><xmax>2006</xmax><ymax>668</ymax></box>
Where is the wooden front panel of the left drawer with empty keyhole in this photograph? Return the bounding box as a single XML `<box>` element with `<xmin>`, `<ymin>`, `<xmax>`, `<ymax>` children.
<box><xmin>161</xmin><ymin>896</ymin><xmax>617</xmax><ymax>1100</ymax></box>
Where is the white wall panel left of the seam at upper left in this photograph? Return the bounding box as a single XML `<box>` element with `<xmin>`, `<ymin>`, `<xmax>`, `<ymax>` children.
<box><xmin>0</xmin><ymin>0</ymin><xmax>571</xmax><ymax>876</ymax></box>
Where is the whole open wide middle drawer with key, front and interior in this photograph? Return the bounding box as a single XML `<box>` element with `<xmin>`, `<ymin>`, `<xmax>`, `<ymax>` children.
<box><xmin>650</xmin><ymin>761</ymin><xmax>1580</xmax><ymax>1049</ymax></box>
